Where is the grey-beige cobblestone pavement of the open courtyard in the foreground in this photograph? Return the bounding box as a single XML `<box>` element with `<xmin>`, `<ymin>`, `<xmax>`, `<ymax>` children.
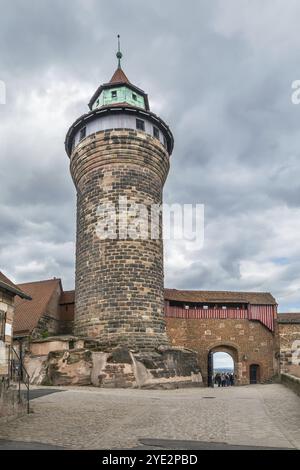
<box><xmin>0</xmin><ymin>384</ymin><xmax>300</xmax><ymax>449</ymax></box>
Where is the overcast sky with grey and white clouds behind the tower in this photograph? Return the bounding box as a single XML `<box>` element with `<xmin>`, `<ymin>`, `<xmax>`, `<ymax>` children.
<box><xmin>0</xmin><ymin>0</ymin><xmax>300</xmax><ymax>311</ymax></box>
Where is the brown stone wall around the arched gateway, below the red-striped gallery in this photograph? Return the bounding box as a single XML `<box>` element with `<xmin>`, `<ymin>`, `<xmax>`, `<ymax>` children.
<box><xmin>166</xmin><ymin>318</ymin><xmax>279</xmax><ymax>384</ymax></box>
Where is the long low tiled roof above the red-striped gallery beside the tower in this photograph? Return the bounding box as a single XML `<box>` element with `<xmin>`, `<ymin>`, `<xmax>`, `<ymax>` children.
<box><xmin>165</xmin><ymin>289</ymin><xmax>276</xmax><ymax>305</ymax></box>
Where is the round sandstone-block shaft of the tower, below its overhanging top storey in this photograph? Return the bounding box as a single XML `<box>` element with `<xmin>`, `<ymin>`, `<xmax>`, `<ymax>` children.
<box><xmin>71</xmin><ymin>129</ymin><xmax>169</xmax><ymax>349</ymax></box>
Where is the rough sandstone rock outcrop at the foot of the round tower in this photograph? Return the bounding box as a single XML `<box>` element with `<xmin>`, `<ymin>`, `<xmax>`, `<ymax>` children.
<box><xmin>26</xmin><ymin>347</ymin><xmax>202</xmax><ymax>388</ymax></box>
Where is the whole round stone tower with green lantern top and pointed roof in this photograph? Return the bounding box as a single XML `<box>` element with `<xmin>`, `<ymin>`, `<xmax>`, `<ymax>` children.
<box><xmin>65</xmin><ymin>41</ymin><xmax>173</xmax><ymax>350</ymax></box>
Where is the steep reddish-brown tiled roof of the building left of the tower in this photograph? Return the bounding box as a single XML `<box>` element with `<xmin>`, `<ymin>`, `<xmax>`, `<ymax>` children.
<box><xmin>13</xmin><ymin>279</ymin><xmax>61</xmax><ymax>334</ymax></box>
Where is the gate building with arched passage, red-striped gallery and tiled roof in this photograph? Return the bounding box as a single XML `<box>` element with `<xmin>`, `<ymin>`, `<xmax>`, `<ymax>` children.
<box><xmin>165</xmin><ymin>289</ymin><xmax>279</xmax><ymax>385</ymax></box>
